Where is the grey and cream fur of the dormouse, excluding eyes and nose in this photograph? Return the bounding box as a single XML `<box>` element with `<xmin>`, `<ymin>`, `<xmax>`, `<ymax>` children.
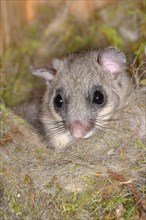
<box><xmin>32</xmin><ymin>47</ymin><xmax>131</xmax><ymax>149</ymax></box>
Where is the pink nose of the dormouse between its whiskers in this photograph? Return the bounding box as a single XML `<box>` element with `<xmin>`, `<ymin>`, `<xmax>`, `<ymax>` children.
<box><xmin>70</xmin><ymin>121</ymin><xmax>90</xmax><ymax>138</ymax></box>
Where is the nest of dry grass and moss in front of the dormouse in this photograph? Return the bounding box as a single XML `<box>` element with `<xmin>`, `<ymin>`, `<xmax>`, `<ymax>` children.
<box><xmin>1</xmin><ymin>85</ymin><xmax>146</xmax><ymax>219</ymax></box>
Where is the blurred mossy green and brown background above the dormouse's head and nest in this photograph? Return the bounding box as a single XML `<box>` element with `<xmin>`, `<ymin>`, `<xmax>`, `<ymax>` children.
<box><xmin>0</xmin><ymin>0</ymin><xmax>146</xmax><ymax>107</ymax></box>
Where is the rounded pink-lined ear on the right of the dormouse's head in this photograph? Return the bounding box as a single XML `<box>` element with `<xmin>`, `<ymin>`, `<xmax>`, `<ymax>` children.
<box><xmin>98</xmin><ymin>47</ymin><xmax>127</xmax><ymax>78</ymax></box>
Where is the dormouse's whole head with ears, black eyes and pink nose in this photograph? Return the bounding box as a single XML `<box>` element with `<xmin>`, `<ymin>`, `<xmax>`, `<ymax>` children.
<box><xmin>31</xmin><ymin>47</ymin><xmax>128</xmax><ymax>139</ymax></box>
